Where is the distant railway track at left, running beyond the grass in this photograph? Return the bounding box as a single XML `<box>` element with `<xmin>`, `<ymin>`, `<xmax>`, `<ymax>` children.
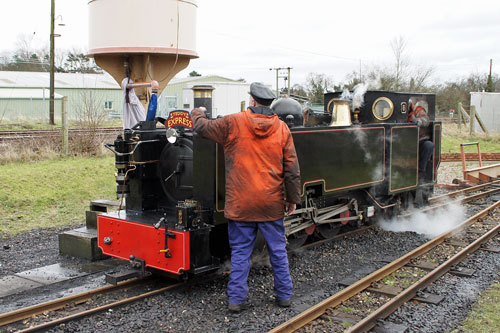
<box><xmin>0</xmin><ymin>127</ymin><xmax>123</xmax><ymax>142</ymax></box>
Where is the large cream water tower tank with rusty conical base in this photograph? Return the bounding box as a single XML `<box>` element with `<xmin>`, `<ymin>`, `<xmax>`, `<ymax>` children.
<box><xmin>88</xmin><ymin>0</ymin><xmax>198</xmax><ymax>103</ymax></box>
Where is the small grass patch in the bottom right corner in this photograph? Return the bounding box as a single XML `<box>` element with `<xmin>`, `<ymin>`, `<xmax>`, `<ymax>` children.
<box><xmin>459</xmin><ymin>282</ymin><xmax>500</xmax><ymax>332</ymax></box>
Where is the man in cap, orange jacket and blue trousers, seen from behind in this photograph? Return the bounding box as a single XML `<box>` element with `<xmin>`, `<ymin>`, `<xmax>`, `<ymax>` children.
<box><xmin>191</xmin><ymin>83</ymin><xmax>300</xmax><ymax>312</ymax></box>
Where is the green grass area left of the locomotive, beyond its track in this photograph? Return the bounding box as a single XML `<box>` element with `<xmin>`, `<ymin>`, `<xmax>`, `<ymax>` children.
<box><xmin>0</xmin><ymin>156</ymin><xmax>115</xmax><ymax>235</ymax></box>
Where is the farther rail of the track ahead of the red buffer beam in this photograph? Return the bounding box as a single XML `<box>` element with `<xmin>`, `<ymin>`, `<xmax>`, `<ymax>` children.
<box><xmin>0</xmin><ymin>279</ymin><xmax>144</xmax><ymax>326</ymax></box>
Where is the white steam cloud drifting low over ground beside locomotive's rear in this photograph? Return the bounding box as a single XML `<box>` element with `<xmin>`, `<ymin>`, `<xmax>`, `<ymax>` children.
<box><xmin>378</xmin><ymin>204</ymin><xmax>465</xmax><ymax>238</ymax></box>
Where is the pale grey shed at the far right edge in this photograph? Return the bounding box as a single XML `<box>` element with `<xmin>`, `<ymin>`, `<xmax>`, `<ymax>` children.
<box><xmin>470</xmin><ymin>92</ymin><xmax>500</xmax><ymax>133</ymax></box>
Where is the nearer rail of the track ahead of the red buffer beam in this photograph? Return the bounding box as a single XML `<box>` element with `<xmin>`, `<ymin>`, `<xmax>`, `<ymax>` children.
<box><xmin>18</xmin><ymin>282</ymin><xmax>185</xmax><ymax>332</ymax></box>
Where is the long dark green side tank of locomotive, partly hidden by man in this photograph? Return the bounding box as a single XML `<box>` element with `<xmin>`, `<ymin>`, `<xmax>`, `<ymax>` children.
<box><xmin>217</xmin><ymin>126</ymin><xmax>385</xmax><ymax>210</ymax></box>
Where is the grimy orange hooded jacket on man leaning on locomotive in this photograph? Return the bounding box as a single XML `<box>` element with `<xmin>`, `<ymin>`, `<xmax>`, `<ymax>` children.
<box><xmin>191</xmin><ymin>109</ymin><xmax>300</xmax><ymax>222</ymax></box>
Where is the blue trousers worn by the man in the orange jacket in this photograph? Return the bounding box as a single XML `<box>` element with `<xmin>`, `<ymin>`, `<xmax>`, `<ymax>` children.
<box><xmin>227</xmin><ymin>220</ymin><xmax>292</xmax><ymax>304</ymax></box>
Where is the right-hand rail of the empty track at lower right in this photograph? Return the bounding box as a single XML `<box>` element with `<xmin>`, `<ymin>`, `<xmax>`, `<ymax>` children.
<box><xmin>347</xmin><ymin>201</ymin><xmax>500</xmax><ymax>333</ymax></box>
